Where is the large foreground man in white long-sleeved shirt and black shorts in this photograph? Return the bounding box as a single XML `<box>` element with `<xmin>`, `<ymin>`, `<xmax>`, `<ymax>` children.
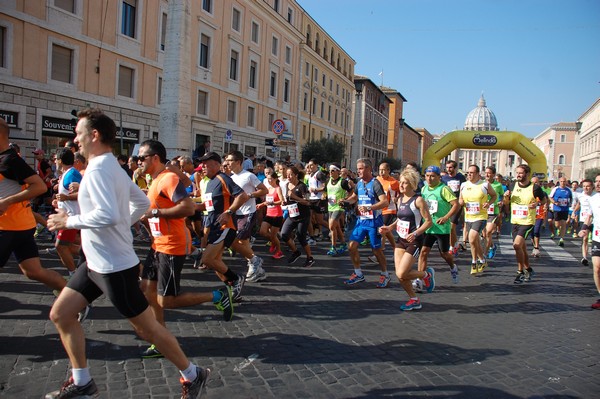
<box><xmin>46</xmin><ymin>109</ymin><xmax>210</xmax><ymax>398</ymax></box>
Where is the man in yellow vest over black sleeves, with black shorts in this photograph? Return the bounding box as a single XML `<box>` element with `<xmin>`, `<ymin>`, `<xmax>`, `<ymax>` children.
<box><xmin>503</xmin><ymin>164</ymin><xmax>546</xmax><ymax>284</ymax></box>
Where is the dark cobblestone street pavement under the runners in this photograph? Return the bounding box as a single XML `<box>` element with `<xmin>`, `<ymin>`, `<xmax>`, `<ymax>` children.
<box><xmin>0</xmin><ymin>227</ymin><xmax>600</xmax><ymax>399</ymax></box>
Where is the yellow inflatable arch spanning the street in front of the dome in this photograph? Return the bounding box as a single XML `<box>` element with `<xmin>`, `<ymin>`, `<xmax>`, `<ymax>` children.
<box><xmin>423</xmin><ymin>130</ymin><xmax>548</xmax><ymax>179</ymax></box>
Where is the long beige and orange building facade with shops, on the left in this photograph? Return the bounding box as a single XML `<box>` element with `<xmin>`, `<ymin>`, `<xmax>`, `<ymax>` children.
<box><xmin>0</xmin><ymin>0</ymin><xmax>355</xmax><ymax>165</ymax></box>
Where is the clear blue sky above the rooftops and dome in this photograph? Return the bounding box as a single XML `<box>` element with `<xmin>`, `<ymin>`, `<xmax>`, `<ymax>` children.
<box><xmin>297</xmin><ymin>0</ymin><xmax>600</xmax><ymax>137</ymax></box>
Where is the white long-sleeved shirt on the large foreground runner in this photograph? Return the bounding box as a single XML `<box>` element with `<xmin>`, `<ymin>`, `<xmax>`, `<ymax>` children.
<box><xmin>67</xmin><ymin>153</ymin><xmax>150</xmax><ymax>274</ymax></box>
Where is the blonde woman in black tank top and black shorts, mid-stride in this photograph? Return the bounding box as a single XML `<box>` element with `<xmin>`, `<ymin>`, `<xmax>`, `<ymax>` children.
<box><xmin>379</xmin><ymin>169</ymin><xmax>435</xmax><ymax>311</ymax></box>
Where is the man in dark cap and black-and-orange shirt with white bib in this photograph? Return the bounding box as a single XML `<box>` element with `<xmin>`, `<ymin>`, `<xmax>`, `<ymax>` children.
<box><xmin>196</xmin><ymin>151</ymin><xmax>249</xmax><ymax>302</ymax></box>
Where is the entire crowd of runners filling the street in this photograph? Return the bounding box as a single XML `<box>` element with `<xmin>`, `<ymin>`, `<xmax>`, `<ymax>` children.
<box><xmin>0</xmin><ymin>109</ymin><xmax>600</xmax><ymax>398</ymax></box>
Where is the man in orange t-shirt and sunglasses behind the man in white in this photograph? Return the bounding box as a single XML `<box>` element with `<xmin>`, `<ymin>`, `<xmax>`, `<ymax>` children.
<box><xmin>138</xmin><ymin>140</ymin><xmax>233</xmax><ymax>358</ymax></box>
